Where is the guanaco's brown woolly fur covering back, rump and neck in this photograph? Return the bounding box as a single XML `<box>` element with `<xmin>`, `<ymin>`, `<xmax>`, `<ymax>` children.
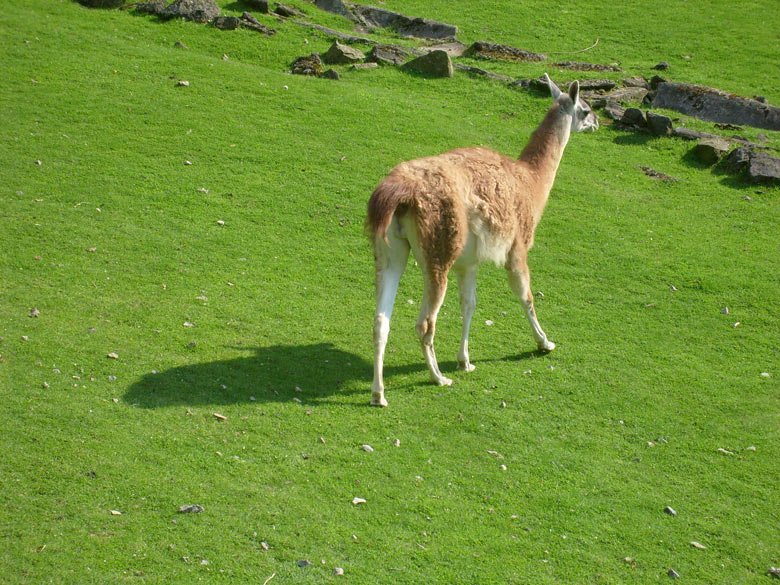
<box><xmin>366</xmin><ymin>98</ymin><xmax>563</xmax><ymax>270</ymax></box>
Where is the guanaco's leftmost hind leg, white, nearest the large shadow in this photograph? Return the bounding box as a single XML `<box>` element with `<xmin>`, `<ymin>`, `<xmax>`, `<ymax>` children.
<box><xmin>371</xmin><ymin>228</ymin><xmax>409</xmax><ymax>406</ymax></box>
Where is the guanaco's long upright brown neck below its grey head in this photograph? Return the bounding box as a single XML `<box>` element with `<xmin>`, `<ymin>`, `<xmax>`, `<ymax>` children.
<box><xmin>518</xmin><ymin>104</ymin><xmax>571</xmax><ymax>222</ymax></box>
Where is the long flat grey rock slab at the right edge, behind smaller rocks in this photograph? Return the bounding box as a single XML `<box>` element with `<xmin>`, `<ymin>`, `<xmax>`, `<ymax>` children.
<box><xmin>653</xmin><ymin>82</ymin><xmax>780</xmax><ymax>130</ymax></box>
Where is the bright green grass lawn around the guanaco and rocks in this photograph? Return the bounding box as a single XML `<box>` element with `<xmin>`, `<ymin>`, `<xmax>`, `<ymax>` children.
<box><xmin>0</xmin><ymin>0</ymin><xmax>780</xmax><ymax>584</ymax></box>
